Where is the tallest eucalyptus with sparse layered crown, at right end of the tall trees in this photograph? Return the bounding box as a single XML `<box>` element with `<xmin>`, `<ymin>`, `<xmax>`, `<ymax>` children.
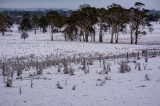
<box><xmin>129</xmin><ymin>2</ymin><xmax>151</xmax><ymax>44</ymax></box>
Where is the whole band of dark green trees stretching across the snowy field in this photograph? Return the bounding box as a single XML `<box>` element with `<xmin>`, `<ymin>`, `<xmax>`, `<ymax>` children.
<box><xmin>0</xmin><ymin>2</ymin><xmax>160</xmax><ymax>44</ymax></box>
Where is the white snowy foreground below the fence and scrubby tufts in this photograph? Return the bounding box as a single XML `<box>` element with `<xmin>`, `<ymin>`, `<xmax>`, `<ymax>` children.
<box><xmin>0</xmin><ymin>57</ymin><xmax>160</xmax><ymax>106</ymax></box>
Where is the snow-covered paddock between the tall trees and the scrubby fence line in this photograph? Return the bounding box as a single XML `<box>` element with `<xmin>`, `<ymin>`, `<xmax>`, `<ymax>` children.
<box><xmin>0</xmin><ymin>23</ymin><xmax>160</xmax><ymax>58</ymax></box>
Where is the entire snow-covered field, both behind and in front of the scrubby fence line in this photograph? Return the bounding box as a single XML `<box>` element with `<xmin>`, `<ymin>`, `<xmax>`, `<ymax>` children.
<box><xmin>0</xmin><ymin>23</ymin><xmax>160</xmax><ymax>106</ymax></box>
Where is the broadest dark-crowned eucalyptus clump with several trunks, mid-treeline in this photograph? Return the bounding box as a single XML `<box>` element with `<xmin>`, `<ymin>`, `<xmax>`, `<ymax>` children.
<box><xmin>64</xmin><ymin>4</ymin><xmax>97</xmax><ymax>42</ymax></box>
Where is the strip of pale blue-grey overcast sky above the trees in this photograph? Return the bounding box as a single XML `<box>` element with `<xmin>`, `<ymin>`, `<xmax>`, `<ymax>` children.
<box><xmin>0</xmin><ymin>0</ymin><xmax>160</xmax><ymax>10</ymax></box>
